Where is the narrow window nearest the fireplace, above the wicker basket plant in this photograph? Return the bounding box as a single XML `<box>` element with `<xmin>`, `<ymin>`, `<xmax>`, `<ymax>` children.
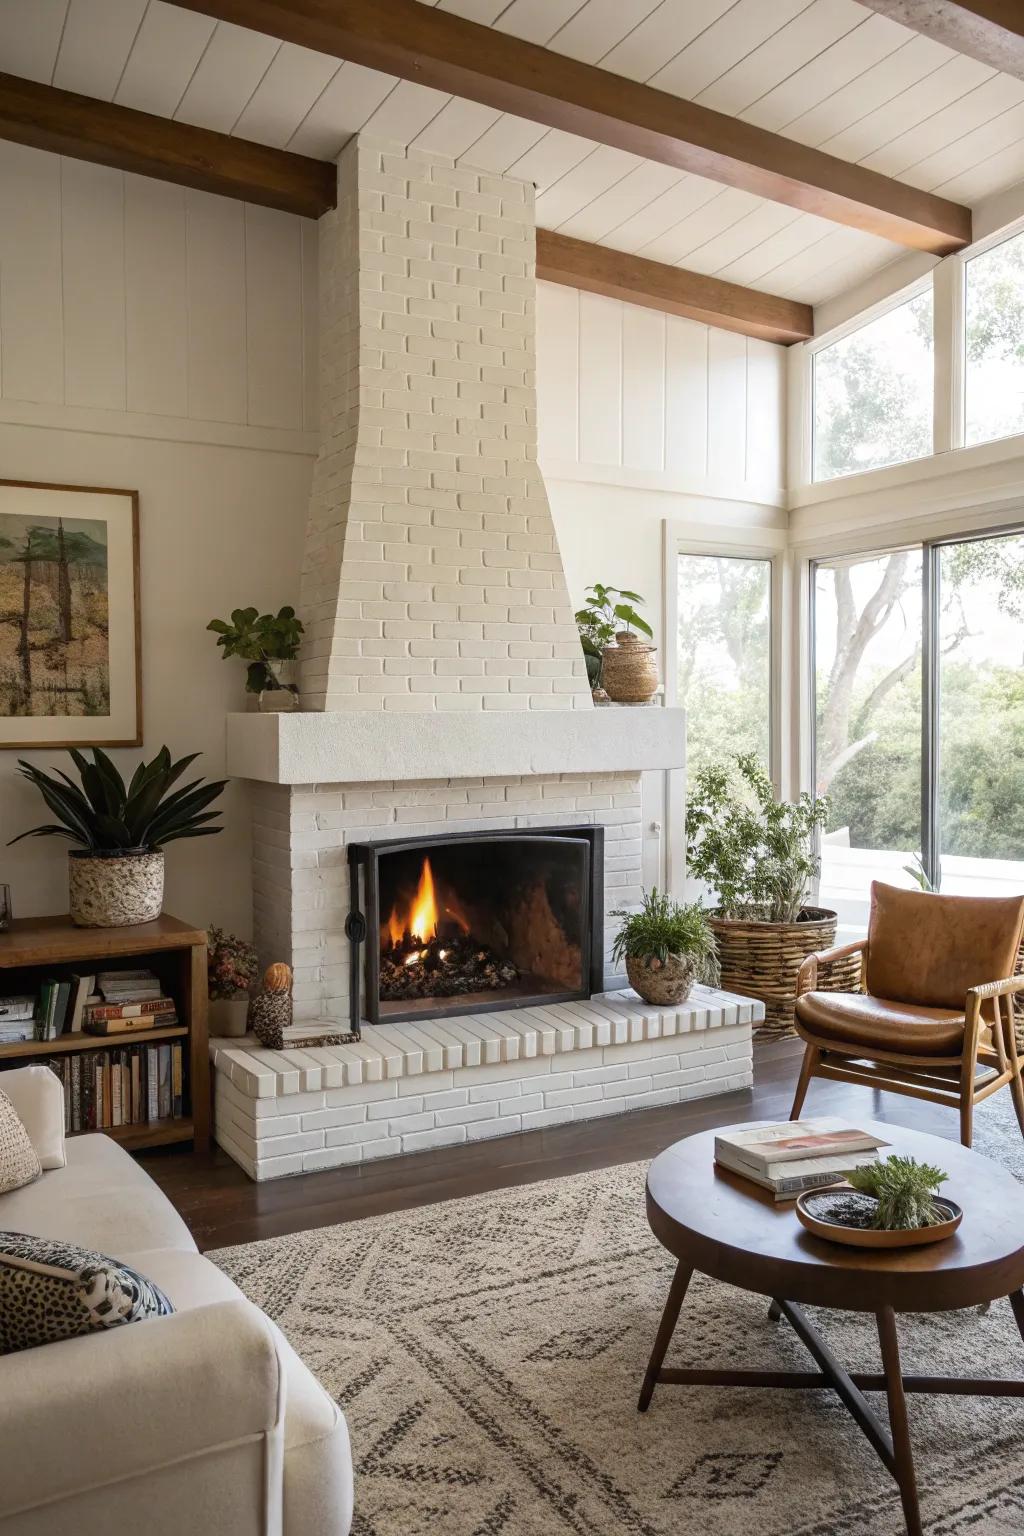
<box><xmin>677</xmin><ymin>554</ymin><xmax>772</xmax><ymax>774</ymax></box>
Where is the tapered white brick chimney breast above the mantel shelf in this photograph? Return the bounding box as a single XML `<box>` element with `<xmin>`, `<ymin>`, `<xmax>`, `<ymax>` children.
<box><xmin>301</xmin><ymin>137</ymin><xmax>591</xmax><ymax>711</ymax></box>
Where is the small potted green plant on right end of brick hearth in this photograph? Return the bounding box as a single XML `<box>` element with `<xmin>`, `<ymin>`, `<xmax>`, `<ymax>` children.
<box><xmin>611</xmin><ymin>889</ymin><xmax>718</xmax><ymax>1006</ymax></box>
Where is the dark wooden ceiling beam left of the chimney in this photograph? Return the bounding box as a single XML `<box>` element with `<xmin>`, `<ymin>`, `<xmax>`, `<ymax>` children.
<box><xmin>0</xmin><ymin>75</ymin><xmax>338</xmax><ymax>218</ymax></box>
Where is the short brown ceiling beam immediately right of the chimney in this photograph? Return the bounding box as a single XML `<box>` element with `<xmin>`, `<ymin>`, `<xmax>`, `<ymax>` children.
<box><xmin>537</xmin><ymin>229</ymin><xmax>814</xmax><ymax>346</ymax></box>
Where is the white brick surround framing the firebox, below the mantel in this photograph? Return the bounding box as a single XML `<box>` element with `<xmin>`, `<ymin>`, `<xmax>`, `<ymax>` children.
<box><xmin>252</xmin><ymin>773</ymin><xmax>642</xmax><ymax>1020</ymax></box>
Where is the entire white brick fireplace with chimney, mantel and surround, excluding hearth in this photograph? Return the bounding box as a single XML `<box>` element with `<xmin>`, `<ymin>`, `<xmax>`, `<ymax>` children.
<box><xmin>227</xmin><ymin>140</ymin><xmax>685</xmax><ymax>1025</ymax></box>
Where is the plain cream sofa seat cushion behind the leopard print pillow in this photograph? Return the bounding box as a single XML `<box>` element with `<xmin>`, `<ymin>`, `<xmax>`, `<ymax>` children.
<box><xmin>0</xmin><ymin>1137</ymin><xmax>195</xmax><ymax>1253</ymax></box>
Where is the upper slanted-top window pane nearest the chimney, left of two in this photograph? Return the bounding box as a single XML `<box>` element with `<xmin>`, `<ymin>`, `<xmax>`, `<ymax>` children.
<box><xmin>812</xmin><ymin>287</ymin><xmax>933</xmax><ymax>481</ymax></box>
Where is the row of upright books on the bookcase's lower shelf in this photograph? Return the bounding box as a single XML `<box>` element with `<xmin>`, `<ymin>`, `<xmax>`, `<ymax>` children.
<box><xmin>45</xmin><ymin>1040</ymin><xmax>184</xmax><ymax>1132</ymax></box>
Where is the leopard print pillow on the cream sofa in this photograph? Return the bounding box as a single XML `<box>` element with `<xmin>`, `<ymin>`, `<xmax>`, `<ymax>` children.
<box><xmin>0</xmin><ymin>1232</ymin><xmax>173</xmax><ymax>1355</ymax></box>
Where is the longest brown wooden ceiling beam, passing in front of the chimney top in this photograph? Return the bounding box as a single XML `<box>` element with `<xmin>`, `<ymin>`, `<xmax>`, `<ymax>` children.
<box><xmin>175</xmin><ymin>0</ymin><xmax>970</xmax><ymax>255</ymax></box>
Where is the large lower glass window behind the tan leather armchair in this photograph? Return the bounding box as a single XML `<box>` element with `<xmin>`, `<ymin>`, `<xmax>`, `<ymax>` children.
<box><xmin>812</xmin><ymin>531</ymin><xmax>1024</xmax><ymax>926</ymax></box>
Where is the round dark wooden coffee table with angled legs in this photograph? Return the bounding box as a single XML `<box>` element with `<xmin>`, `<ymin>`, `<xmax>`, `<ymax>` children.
<box><xmin>639</xmin><ymin>1121</ymin><xmax>1024</xmax><ymax>1536</ymax></box>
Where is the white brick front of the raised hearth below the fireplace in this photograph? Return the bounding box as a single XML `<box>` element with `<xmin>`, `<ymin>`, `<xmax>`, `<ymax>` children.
<box><xmin>213</xmin><ymin>989</ymin><xmax>763</xmax><ymax>1180</ymax></box>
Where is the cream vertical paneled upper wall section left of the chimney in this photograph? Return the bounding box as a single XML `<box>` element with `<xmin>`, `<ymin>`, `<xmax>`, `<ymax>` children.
<box><xmin>0</xmin><ymin>143</ymin><xmax>318</xmax><ymax>430</ymax></box>
